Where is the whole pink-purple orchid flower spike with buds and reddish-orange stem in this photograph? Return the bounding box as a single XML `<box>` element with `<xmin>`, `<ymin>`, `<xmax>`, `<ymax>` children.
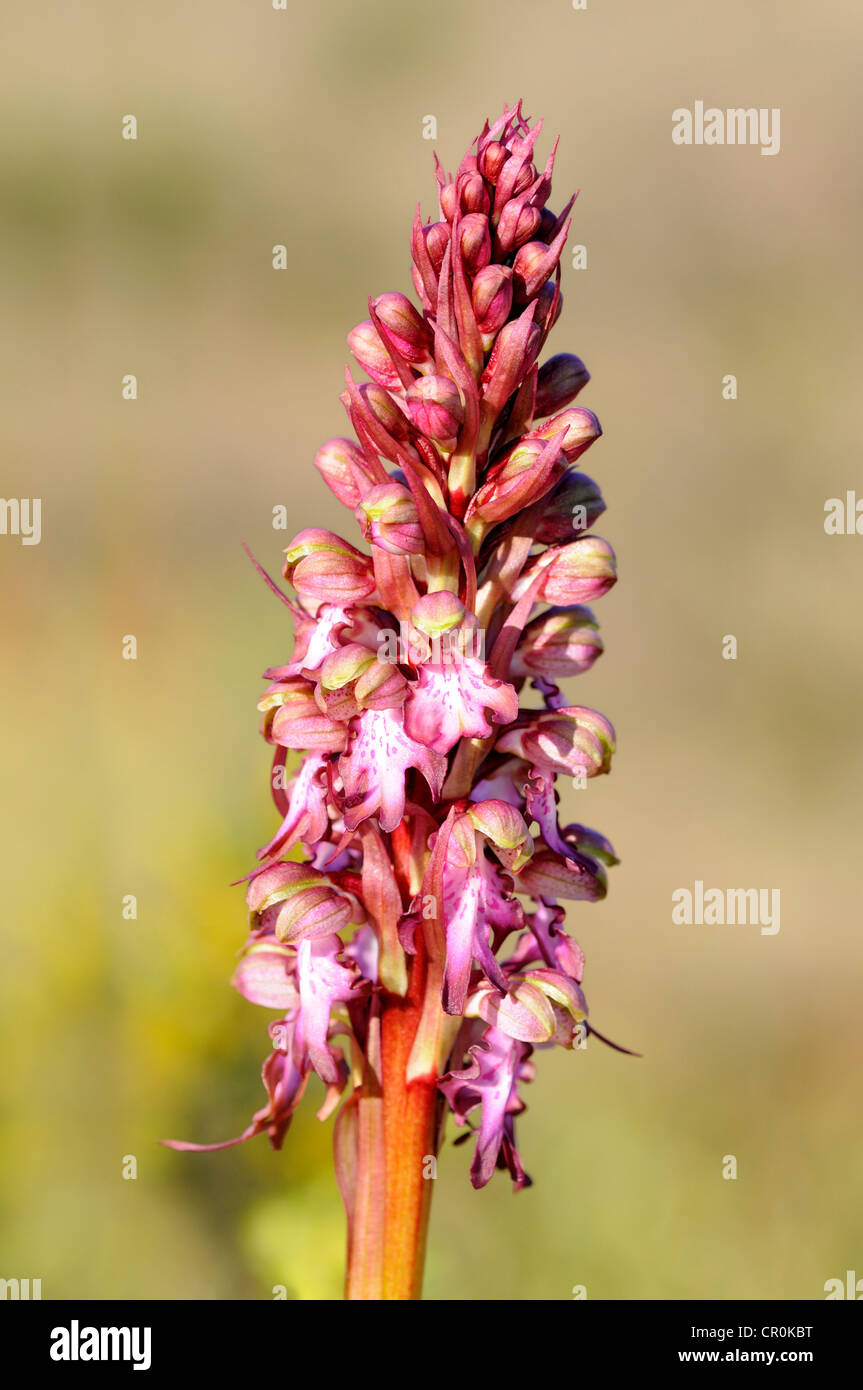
<box><xmin>163</xmin><ymin>106</ymin><xmax>616</xmax><ymax>1298</ymax></box>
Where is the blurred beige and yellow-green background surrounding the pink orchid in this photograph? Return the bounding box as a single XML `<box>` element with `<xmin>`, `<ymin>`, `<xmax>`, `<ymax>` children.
<box><xmin>0</xmin><ymin>0</ymin><xmax>863</xmax><ymax>1300</ymax></box>
